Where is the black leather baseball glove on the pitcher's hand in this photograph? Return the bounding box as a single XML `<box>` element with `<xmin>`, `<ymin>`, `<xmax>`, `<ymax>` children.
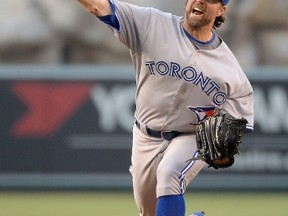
<box><xmin>193</xmin><ymin>113</ymin><xmax>247</xmax><ymax>169</ymax></box>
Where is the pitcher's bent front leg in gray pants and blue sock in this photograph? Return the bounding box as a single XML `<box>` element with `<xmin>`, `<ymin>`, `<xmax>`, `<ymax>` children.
<box><xmin>157</xmin><ymin>135</ymin><xmax>205</xmax><ymax>216</ymax></box>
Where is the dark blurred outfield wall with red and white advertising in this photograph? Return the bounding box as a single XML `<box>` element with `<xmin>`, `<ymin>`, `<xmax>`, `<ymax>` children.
<box><xmin>0</xmin><ymin>66</ymin><xmax>288</xmax><ymax>190</ymax></box>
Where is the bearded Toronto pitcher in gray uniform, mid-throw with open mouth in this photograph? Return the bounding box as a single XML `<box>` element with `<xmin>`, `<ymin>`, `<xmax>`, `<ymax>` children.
<box><xmin>78</xmin><ymin>0</ymin><xmax>254</xmax><ymax>216</ymax></box>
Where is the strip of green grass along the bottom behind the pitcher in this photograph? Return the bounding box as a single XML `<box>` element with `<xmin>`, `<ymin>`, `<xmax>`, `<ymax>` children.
<box><xmin>0</xmin><ymin>192</ymin><xmax>288</xmax><ymax>216</ymax></box>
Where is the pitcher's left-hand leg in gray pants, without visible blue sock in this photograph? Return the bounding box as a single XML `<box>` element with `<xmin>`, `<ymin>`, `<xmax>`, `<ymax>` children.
<box><xmin>130</xmin><ymin>127</ymin><xmax>168</xmax><ymax>216</ymax></box>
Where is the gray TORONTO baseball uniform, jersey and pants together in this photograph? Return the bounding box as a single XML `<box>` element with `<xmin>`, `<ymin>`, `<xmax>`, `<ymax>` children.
<box><xmin>98</xmin><ymin>0</ymin><xmax>254</xmax><ymax>215</ymax></box>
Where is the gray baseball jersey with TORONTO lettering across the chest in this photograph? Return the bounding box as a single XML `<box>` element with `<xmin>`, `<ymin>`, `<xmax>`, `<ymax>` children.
<box><xmin>105</xmin><ymin>1</ymin><xmax>253</xmax><ymax>131</ymax></box>
